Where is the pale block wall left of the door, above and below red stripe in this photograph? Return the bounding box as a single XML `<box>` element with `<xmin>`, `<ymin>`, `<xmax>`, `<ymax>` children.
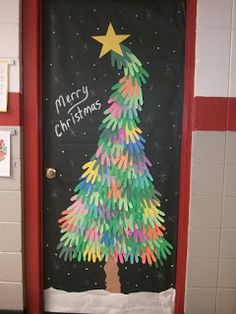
<box><xmin>0</xmin><ymin>0</ymin><xmax>23</xmax><ymax>310</ymax></box>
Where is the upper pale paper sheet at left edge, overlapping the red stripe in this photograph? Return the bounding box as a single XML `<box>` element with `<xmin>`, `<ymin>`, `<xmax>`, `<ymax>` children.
<box><xmin>0</xmin><ymin>62</ymin><xmax>8</xmax><ymax>112</ymax></box>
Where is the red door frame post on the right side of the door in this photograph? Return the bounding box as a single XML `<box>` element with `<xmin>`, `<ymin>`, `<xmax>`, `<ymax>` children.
<box><xmin>175</xmin><ymin>0</ymin><xmax>197</xmax><ymax>314</ymax></box>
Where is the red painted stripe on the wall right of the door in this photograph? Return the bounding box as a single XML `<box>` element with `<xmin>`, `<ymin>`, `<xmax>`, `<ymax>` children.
<box><xmin>193</xmin><ymin>97</ymin><xmax>236</xmax><ymax>131</ymax></box>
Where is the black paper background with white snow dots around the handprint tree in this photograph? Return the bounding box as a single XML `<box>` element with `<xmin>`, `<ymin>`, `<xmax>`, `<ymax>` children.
<box><xmin>43</xmin><ymin>0</ymin><xmax>186</xmax><ymax>293</ymax></box>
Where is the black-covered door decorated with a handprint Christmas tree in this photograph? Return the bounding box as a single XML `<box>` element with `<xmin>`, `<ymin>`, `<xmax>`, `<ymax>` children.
<box><xmin>43</xmin><ymin>0</ymin><xmax>185</xmax><ymax>313</ymax></box>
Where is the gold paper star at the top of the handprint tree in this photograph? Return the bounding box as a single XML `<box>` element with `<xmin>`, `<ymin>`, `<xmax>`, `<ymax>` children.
<box><xmin>92</xmin><ymin>23</ymin><xmax>130</xmax><ymax>58</ymax></box>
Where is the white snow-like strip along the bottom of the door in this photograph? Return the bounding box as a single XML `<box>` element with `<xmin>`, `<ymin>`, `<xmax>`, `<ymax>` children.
<box><xmin>44</xmin><ymin>288</ymin><xmax>175</xmax><ymax>314</ymax></box>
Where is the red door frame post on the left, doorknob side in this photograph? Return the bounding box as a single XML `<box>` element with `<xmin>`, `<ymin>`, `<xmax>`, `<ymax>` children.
<box><xmin>22</xmin><ymin>0</ymin><xmax>43</xmax><ymax>314</ymax></box>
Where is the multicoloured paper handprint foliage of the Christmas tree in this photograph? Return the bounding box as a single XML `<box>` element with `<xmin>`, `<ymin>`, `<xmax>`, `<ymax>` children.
<box><xmin>58</xmin><ymin>28</ymin><xmax>173</xmax><ymax>265</ymax></box>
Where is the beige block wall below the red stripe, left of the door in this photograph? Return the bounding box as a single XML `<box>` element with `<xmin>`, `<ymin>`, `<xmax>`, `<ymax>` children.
<box><xmin>0</xmin><ymin>126</ymin><xmax>23</xmax><ymax>310</ymax></box>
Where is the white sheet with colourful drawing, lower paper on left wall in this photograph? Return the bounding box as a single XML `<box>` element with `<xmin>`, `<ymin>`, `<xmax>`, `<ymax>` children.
<box><xmin>0</xmin><ymin>131</ymin><xmax>11</xmax><ymax>177</ymax></box>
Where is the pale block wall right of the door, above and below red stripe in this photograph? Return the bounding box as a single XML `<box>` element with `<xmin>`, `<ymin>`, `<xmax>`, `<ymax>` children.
<box><xmin>185</xmin><ymin>0</ymin><xmax>236</xmax><ymax>314</ymax></box>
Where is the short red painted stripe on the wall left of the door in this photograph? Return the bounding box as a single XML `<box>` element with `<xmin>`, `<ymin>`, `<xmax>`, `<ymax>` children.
<box><xmin>0</xmin><ymin>93</ymin><xmax>21</xmax><ymax>125</ymax></box>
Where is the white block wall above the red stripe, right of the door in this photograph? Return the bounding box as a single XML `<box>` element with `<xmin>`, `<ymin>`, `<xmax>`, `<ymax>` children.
<box><xmin>195</xmin><ymin>0</ymin><xmax>233</xmax><ymax>97</ymax></box>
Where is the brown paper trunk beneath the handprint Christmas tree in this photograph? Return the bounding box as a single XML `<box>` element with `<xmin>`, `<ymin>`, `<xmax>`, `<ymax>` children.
<box><xmin>104</xmin><ymin>256</ymin><xmax>120</xmax><ymax>293</ymax></box>
